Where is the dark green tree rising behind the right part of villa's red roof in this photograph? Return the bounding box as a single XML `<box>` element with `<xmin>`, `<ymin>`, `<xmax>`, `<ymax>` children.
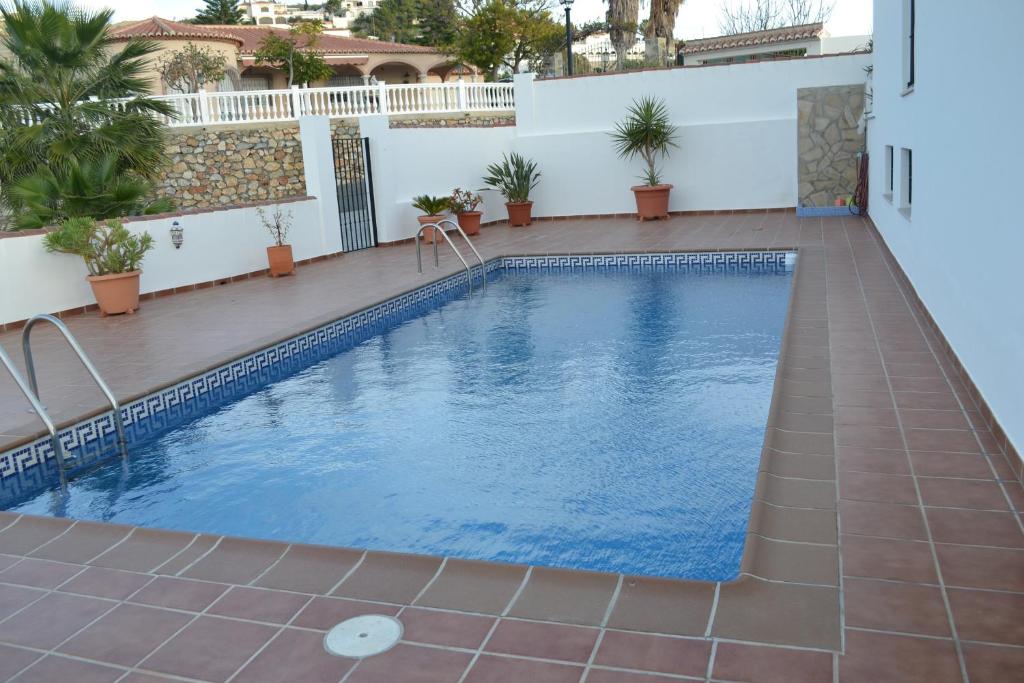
<box><xmin>352</xmin><ymin>0</ymin><xmax>459</xmax><ymax>47</ymax></box>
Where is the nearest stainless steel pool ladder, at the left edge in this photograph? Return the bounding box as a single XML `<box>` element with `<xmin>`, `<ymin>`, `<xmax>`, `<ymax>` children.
<box><xmin>0</xmin><ymin>313</ymin><xmax>128</xmax><ymax>488</ymax></box>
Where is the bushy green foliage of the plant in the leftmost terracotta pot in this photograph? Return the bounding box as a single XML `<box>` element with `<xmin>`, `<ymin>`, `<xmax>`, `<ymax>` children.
<box><xmin>43</xmin><ymin>218</ymin><xmax>153</xmax><ymax>275</ymax></box>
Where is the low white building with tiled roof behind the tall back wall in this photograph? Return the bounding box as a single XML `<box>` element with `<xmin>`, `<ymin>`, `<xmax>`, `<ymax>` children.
<box><xmin>676</xmin><ymin>23</ymin><xmax>871</xmax><ymax>67</ymax></box>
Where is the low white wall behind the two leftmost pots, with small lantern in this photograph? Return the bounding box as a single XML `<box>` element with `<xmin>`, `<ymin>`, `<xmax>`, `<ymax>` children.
<box><xmin>0</xmin><ymin>199</ymin><xmax>321</xmax><ymax>323</ymax></box>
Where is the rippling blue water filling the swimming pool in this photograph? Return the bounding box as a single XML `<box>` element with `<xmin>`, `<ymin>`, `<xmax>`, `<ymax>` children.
<box><xmin>11</xmin><ymin>268</ymin><xmax>791</xmax><ymax>580</ymax></box>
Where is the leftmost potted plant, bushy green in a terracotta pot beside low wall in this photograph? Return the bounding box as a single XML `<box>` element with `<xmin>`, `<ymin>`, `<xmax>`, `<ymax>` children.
<box><xmin>43</xmin><ymin>218</ymin><xmax>153</xmax><ymax>316</ymax></box>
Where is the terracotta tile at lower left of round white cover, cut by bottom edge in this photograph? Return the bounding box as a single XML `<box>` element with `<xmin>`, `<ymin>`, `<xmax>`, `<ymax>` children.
<box><xmin>232</xmin><ymin>629</ymin><xmax>355</xmax><ymax>683</ymax></box>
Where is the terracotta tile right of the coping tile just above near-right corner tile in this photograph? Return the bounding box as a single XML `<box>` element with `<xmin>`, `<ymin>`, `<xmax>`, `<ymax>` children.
<box><xmin>842</xmin><ymin>535</ymin><xmax>938</xmax><ymax>584</ymax></box>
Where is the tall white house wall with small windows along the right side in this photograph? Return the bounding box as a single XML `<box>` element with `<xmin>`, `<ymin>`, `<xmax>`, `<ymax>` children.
<box><xmin>867</xmin><ymin>0</ymin><xmax>1024</xmax><ymax>452</ymax></box>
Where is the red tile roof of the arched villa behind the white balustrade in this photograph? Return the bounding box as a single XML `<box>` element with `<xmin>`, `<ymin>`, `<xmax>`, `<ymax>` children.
<box><xmin>111</xmin><ymin>16</ymin><xmax>437</xmax><ymax>54</ymax></box>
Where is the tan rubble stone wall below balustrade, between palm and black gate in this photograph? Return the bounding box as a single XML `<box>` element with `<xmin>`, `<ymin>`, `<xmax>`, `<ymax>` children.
<box><xmin>154</xmin><ymin>119</ymin><xmax>358</xmax><ymax>209</ymax></box>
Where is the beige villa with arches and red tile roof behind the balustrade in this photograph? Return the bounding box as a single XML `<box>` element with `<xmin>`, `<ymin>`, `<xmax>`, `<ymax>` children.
<box><xmin>112</xmin><ymin>16</ymin><xmax>468</xmax><ymax>94</ymax></box>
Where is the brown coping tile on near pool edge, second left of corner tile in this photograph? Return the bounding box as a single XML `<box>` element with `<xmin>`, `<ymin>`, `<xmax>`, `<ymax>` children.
<box><xmin>509</xmin><ymin>567</ymin><xmax>617</xmax><ymax>626</ymax></box>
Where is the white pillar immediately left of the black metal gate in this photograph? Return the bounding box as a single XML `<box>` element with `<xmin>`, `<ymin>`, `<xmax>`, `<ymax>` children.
<box><xmin>299</xmin><ymin>116</ymin><xmax>341</xmax><ymax>254</ymax></box>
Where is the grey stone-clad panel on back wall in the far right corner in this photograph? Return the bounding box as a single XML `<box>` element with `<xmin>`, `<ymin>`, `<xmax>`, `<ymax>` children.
<box><xmin>797</xmin><ymin>84</ymin><xmax>864</xmax><ymax>207</ymax></box>
